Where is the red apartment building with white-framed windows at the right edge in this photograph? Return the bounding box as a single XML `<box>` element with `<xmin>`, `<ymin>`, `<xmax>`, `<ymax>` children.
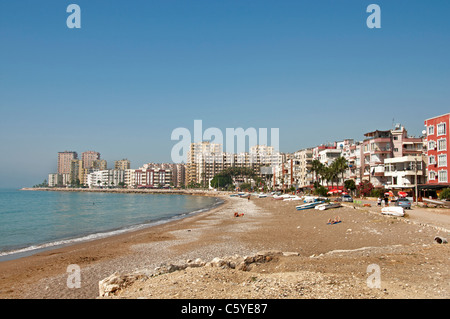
<box><xmin>425</xmin><ymin>113</ymin><xmax>450</xmax><ymax>190</ymax></box>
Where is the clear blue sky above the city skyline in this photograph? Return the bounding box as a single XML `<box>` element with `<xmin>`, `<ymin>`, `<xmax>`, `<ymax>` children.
<box><xmin>0</xmin><ymin>0</ymin><xmax>450</xmax><ymax>187</ymax></box>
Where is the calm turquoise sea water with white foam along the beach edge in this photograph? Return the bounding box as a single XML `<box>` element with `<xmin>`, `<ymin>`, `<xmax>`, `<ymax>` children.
<box><xmin>0</xmin><ymin>189</ymin><xmax>220</xmax><ymax>261</ymax></box>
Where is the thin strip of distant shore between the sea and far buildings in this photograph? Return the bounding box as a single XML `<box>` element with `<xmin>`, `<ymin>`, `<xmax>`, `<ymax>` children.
<box><xmin>20</xmin><ymin>187</ymin><xmax>232</xmax><ymax>197</ymax></box>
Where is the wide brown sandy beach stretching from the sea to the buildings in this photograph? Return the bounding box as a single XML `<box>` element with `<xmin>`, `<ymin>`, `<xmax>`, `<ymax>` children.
<box><xmin>0</xmin><ymin>195</ymin><xmax>450</xmax><ymax>299</ymax></box>
